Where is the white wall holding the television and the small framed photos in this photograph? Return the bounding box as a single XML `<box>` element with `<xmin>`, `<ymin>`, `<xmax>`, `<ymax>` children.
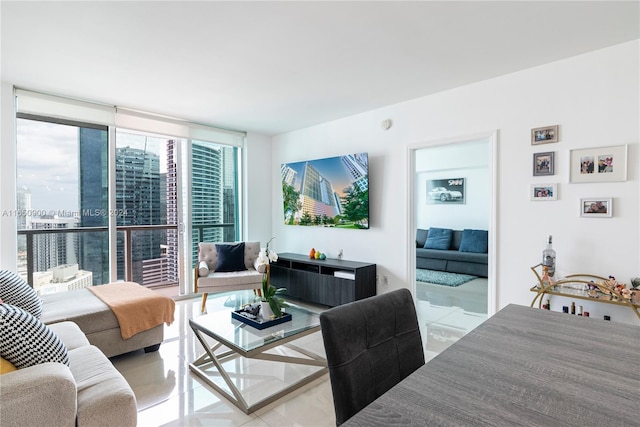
<box><xmin>271</xmin><ymin>40</ymin><xmax>640</xmax><ymax>321</ymax></box>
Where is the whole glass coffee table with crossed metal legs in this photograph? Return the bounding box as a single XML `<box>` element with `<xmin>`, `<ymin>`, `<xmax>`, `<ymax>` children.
<box><xmin>189</xmin><ymin>304</ymin><xmax>327</xmax><ymax>414</ymax></box>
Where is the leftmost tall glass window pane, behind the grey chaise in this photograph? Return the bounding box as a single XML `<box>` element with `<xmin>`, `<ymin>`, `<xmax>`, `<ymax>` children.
<box><xmin>15</xmin><ymin>115</ymin><xmax>109</xmax><ymax>294</ymax></box>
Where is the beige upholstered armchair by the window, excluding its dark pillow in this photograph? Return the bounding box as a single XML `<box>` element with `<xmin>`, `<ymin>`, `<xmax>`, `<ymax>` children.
<box><xmin>194</xmin><ymin>242</ymin><xmax>266</xmax><ymax>313</ymax></box>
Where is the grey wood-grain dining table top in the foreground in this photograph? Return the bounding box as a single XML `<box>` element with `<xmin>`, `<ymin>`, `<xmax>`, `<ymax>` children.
<box><xmin>343</xmin><ymin>305</ymin><xmax>640</xmax><ymax>427</ymax></box>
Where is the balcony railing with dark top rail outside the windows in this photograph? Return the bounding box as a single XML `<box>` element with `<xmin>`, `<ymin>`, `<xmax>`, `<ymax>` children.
<box><xmin>18</xmin><ymin>223</ymin><xmax>235</xmax><ymax>292</ymax></box>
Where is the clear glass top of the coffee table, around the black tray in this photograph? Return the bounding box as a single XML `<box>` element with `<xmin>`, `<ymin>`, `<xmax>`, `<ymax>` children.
<box><xmin>189</xmin><ymin>303</ymin><xmax>320</xmax><ymax>356</ymax></box>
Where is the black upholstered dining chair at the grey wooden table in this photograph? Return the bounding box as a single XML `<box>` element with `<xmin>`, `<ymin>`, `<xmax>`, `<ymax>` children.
<box><xmin>320</xmin><ymin>289</ymin><xmax>424</xmax><ymax>425</ymax></box>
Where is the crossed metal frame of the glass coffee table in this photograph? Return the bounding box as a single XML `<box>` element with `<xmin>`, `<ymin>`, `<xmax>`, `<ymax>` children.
<box><xmin>189</xmin><ymin>308</ymin><xmax>328</xmax><ymax>414</ymax></box>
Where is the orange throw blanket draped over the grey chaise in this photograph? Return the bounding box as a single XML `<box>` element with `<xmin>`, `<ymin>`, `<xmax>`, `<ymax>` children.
<box><xmin>88</xmin><ymin>282</ymin><xmax>176</xmax><ymax>340</ymax></box>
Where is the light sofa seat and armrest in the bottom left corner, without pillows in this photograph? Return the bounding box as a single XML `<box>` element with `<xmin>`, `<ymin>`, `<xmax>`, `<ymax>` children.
<box><xmin>0</xmin><ymin>322</ymin><xmax>137</xmax><ymax>427</ymax></box>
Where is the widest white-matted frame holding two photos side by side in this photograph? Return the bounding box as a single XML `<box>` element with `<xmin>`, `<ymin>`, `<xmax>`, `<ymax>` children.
<box><xmin>570</xmin><ymin>145</ymin><xmax>627</xmax><ymax>182</ymax></box>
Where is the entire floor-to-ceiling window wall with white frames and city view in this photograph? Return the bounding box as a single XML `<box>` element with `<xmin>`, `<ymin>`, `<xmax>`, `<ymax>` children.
<box><xmin>14</xmin><ymin>90</ymin><xmax>244</xmax><ymax>295</ymax></box>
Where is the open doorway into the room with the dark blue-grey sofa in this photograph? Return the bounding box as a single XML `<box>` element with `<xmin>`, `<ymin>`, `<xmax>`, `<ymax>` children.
<box><xmin>408</xmin><ymin>132</ymin><xmax>497</xmax><ymax>359</ymax></box>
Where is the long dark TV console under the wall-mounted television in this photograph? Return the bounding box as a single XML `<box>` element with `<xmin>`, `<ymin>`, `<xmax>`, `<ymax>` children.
<box><xmin>271</xmin><ymin>253</ymin><xmax>376</xmax><ymax>307</ymax></box>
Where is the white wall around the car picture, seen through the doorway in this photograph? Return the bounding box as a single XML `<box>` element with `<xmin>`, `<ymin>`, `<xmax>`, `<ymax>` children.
<box><xmin>414</xmin><ymin>140</ymin><xmax>491</xmax><ymax>230</ymax></box>
